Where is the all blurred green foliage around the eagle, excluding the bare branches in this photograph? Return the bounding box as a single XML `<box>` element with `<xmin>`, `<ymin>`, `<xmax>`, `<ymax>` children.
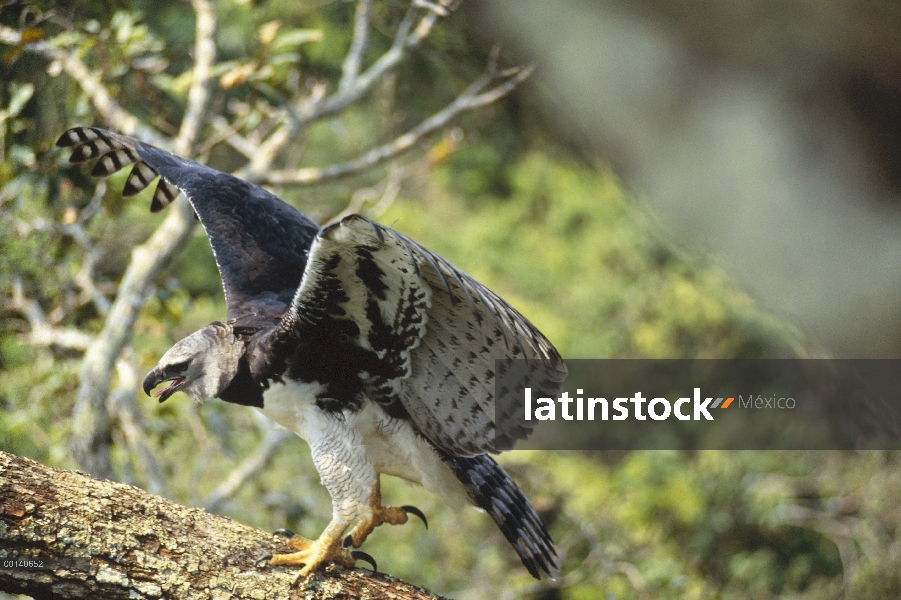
<box><xmin>0</xmin><ymin>0</ymin><xmax>901</xmax><ymax>600</ymax></box>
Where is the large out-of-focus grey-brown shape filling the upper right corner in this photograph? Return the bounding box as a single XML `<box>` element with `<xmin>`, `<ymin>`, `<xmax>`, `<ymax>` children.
<box><xmin>477</xmin><ymin>0</ymin><xmax>901</xmax><ymax>358</ymax></box>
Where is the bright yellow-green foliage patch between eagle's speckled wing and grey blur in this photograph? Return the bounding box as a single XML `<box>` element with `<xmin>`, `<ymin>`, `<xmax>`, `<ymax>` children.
<box><xmin>383</xmin><ymin>144</ymin><xmax>800</xmax><ymax>358</ymax></box>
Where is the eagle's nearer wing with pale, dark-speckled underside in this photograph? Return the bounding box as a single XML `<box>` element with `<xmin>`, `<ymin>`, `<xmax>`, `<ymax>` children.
<box><xmin>274</xmin><ymin>215</ymin><xmax>566</xmax><ymax>455</ymax></box>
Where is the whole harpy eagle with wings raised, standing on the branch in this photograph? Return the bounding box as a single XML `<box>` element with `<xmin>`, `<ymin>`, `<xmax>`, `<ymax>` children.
<box><xmin>57</xmin><ymin>127</ymin><xmax>566</xmax><ymax>578</ymax></box>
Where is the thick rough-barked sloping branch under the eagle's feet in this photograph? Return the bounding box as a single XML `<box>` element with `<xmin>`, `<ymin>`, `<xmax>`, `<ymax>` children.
<box><xmin>0</xmin><ymin>452</ymin><xmax>438</xmax><ymax>600</ymax></box>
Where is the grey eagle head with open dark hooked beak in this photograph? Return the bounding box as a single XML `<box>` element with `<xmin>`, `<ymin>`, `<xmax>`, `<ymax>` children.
<box><xmin>143</xmin><ymin>321</ymin><xmax>244</xmax><ymax>402</ymax></box>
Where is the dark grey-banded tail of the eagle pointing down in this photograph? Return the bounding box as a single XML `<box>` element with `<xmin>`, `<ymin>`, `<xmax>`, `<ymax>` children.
<box><xmin>442</xmin><ymin>454</ymin><xmax>560</xmax><ymax>579</ymax></box>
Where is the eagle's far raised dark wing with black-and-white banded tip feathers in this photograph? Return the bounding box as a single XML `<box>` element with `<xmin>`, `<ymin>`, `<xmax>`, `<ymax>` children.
<box><xmin>56</xmin><ymin>127</ymin><xmax>319</xmax><ymax>318</ymax></box>
